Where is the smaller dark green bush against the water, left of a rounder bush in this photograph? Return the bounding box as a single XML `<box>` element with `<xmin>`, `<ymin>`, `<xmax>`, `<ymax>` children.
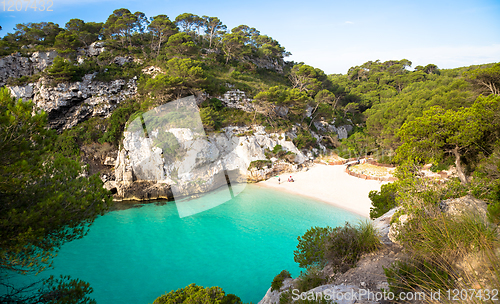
<box><xmin>293</xmin><ymin>226</ymin><xmax>333</xmax><ymax>268</ymax></box>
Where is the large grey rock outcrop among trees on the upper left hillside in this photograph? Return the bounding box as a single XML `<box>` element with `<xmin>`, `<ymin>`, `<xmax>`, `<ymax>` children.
<box><xmin>9</xmin><ymin>74</ymin><xmax>137</xmax><ymax>130</ymax></box>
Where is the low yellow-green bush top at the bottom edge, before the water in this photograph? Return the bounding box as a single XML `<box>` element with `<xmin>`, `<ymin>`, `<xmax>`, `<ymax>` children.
<box><xmin>153</xmin><ymin>284</ymin><xmax>242</xmax><ymax>304</ymax></box>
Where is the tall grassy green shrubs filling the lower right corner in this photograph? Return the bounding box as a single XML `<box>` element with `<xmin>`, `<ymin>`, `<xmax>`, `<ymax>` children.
<box><xmin>385</xmin><ymin>175</ymin><xmax>500</xmax><ymax>302</ymax></box>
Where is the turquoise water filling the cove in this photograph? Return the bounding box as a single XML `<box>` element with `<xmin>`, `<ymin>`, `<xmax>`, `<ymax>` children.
<box><xmin>11</xmin><ymin>185</ymin><xmax>362</xmax><ymax>304</ymax></box>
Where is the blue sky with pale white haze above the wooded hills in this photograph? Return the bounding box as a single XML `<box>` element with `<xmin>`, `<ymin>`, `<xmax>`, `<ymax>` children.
<box><xmin>0</xmin><ymin>0</ymin><xmax>500</xmax><ymax>74</ymax></box>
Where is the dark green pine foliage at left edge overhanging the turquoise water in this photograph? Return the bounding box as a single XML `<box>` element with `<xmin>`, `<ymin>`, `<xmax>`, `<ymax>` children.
<box><xmin>0</xmin><ymin>88</ymin><xmax>112</xmax><ymax>299</ymax></box>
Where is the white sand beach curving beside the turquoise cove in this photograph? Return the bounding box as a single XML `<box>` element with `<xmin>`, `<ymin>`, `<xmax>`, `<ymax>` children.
<box><xmin>257</xmin><ymin>165</ymin><xmax>387</xmax><ymax>218</ymax></box>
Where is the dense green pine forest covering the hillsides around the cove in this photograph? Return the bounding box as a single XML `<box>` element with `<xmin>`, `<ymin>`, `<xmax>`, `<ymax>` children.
<box><xmin>0</xmin><ymin>8</ymin><xmax>500</xmax><ymax>303</ymax></box>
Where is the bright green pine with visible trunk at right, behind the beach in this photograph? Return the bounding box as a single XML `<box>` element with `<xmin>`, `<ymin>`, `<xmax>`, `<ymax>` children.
<box><xmin>396</xmin><ymin>95</ymin><xmax>500</xmax><ymax>184</ymax></box>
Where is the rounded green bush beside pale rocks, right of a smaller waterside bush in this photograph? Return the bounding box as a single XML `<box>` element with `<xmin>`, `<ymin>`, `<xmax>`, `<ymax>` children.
<box><xmin>325</xmin><ymin>222</ymin><xmax>380</xmax><ymax>272</ymax></box>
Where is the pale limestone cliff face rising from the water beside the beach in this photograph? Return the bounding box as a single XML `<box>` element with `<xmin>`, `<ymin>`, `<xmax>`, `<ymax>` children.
<box><xmin>106</xmin><ymin>126</ymin><xmax>306</xmax><ymax>200</ymax></box>
